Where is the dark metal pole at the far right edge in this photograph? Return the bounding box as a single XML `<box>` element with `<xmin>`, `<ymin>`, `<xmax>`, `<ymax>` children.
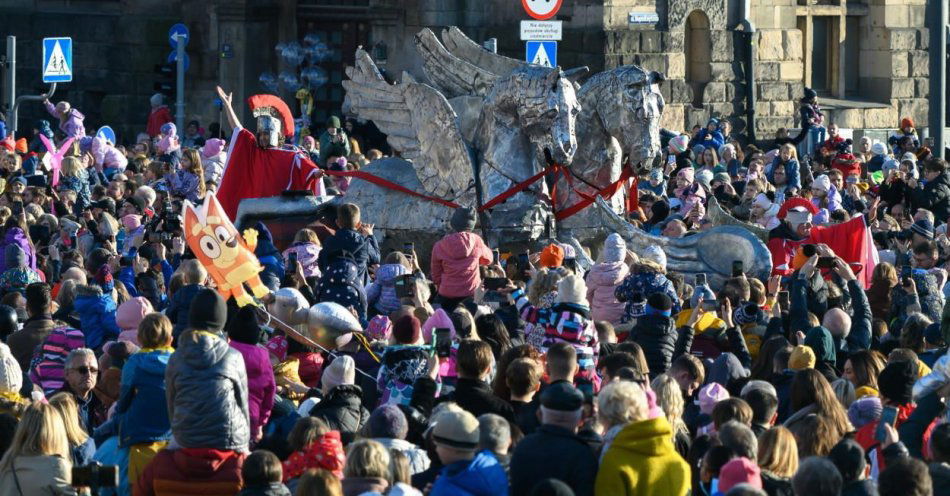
<box><xmin>927</xmin><ymin>0</ymin><xmax>947</xmax><ymax>158</ymax></box>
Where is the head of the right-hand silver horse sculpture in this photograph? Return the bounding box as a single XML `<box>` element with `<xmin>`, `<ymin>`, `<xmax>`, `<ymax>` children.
<box><xmin>578</xmin><ymin>65</ymin><xmax>665</xmax><ymax>173</ymax></box>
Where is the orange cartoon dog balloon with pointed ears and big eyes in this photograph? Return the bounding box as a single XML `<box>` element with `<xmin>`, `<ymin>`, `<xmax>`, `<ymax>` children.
<box><xmin>184</xmin><ymin>193</ymin><xmax>270</xmax><ymax>307</ymax></box>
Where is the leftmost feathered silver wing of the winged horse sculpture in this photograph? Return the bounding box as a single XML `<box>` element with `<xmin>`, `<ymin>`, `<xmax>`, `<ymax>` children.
<box><xmin>343</xmin><ymin>49</ymin><xmax>472</xmax><ymax>199</ymax></box>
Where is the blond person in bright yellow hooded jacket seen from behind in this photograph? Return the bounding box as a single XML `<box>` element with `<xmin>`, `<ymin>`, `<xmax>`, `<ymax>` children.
<box><xmin>594</xmin><ymin>381</ymin><xmax>690</xmax><ymax>496</ymax></box>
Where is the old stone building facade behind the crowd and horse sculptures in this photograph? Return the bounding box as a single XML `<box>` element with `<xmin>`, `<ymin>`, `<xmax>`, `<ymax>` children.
<box><xmin>0</xmin><ymin>0</ymin><xmax>929</xmax><ymax>140</ymax></box>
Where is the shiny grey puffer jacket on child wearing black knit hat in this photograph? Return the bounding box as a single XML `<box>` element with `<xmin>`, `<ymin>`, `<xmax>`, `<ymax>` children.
<box><xmin>165</xmin><ymin>330</ymin><xmax>251</xmax><ymax>451</ymax></box>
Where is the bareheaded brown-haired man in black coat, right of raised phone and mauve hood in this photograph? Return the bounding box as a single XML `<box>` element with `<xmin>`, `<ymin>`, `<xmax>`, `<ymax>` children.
<box><xmin>439</xmin><ymin>339</ymin><xmax>515</xmax><ymax>423</ymax></box>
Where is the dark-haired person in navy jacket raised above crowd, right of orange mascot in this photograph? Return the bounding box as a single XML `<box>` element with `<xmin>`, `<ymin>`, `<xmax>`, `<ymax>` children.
<box><xmin>317</xmin><ymin>203</ymin><xmax>379</xmax><ymax>286</ymax></box>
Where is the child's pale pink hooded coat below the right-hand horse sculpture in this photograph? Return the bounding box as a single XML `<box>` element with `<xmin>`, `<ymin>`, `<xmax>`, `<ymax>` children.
<box><xmin>585</xmin><ymin>233</ymin><xmax>630</xmax><ymax>326</ymax></box>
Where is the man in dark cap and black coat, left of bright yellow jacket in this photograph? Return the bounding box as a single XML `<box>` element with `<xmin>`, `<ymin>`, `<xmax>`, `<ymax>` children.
<box><xmin>509</xmin><ymin>382</ymin><xmax>597</xmax><ymax>496</ymax></box>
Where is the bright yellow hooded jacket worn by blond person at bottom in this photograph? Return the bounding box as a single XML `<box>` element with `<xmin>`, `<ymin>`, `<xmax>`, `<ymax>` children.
<box><xmin>594</xmin><ymin>417</ymin><xmax>690</xmax><ymax>496</ymax></box>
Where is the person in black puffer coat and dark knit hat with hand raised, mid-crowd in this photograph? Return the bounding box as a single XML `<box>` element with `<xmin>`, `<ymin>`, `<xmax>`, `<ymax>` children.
<box><xmin>627</xmin><ymin>293</ymin><xmax>696</xmax><ymax>379</ymax></box>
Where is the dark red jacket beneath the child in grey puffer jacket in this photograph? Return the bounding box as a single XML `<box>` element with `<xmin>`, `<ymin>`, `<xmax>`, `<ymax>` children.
<box><xmin>139</xmin><ymin>448</ymin><xmax>247</xmax><ymax>496</ymax></box>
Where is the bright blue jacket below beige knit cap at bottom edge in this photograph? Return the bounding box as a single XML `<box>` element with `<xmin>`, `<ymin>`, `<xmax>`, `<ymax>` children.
<box><xmin>429</xmin><ymin>451</ymin><xmax>508</xmax><ymax>496</ymax></box>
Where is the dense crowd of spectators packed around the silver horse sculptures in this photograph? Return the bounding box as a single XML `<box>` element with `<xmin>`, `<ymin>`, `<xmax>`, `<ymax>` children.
<box><xmin>0</xmin><ymin>84</ymin><xmax>950</xmax><ymax>496</ymax></box>
